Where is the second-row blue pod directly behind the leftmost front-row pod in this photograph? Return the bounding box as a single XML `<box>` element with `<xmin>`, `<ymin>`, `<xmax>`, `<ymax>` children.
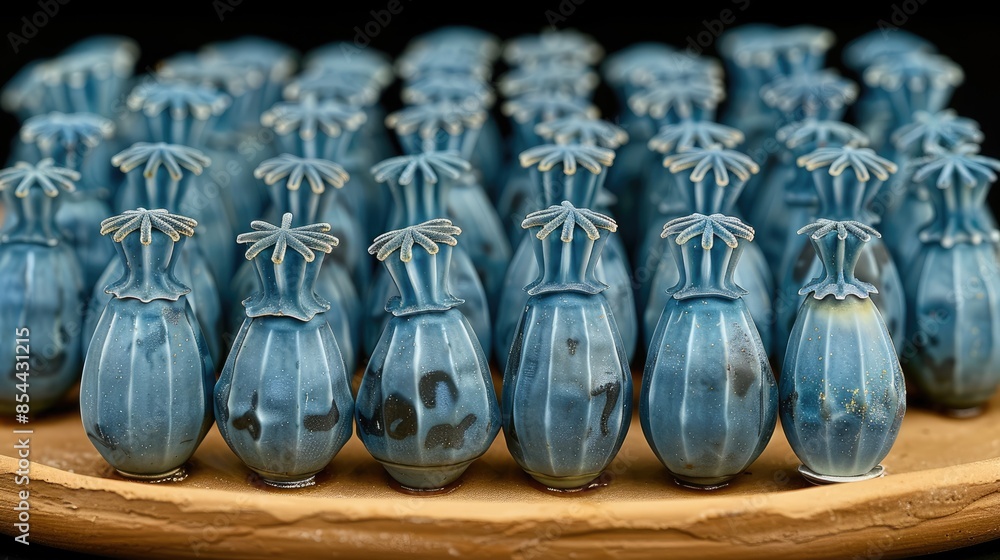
<box><xmin>83</xmin><ymin>142</ymin><xmax>222</xmax><ymax>363</ymax></box>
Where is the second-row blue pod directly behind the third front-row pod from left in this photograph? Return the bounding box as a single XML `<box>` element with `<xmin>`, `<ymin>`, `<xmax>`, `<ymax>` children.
<box><xmin>364</xmin><ymin>151</ymin><xmax>493</xmax><ymax>354</ymax></box>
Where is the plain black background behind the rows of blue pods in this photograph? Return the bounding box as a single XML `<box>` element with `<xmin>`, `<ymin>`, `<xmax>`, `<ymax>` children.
<box><xmin>0</xmin><ymin>0</ymin><xmax>1000</xmax><ymax>557</ymax></box>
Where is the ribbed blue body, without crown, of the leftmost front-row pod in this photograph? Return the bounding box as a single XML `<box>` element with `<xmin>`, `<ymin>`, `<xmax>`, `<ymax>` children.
<box><xmin>80</xmin><ymin>296</ymin><xmax>215</xmax><ymax>477</ymax></box>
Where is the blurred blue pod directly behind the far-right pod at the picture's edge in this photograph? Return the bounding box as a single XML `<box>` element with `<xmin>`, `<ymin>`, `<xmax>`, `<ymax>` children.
<box><xmin>873</xmin><ymin>109</ymin><xmax>989</xmax><ymax>270</ymax></box>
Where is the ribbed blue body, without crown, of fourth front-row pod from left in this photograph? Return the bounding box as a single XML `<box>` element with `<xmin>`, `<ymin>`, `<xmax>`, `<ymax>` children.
<box><xmin>502</xmin><ymin>291</ymin><xmax>632</xmax><ymax>488</ymax></box>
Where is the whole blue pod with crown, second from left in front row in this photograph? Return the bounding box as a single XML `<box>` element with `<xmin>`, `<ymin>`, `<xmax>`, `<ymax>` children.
<box><xmin>215</xmin><ymin>214</ymin><xmax>354</xmax><ymax>488</ymax></box>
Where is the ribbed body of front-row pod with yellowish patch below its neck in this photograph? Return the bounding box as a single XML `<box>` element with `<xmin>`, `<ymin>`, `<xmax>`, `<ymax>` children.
<box><xmin>779</xmin><ymin>295</ymin><xmax>906</xmax><ymax>476</ymax></box>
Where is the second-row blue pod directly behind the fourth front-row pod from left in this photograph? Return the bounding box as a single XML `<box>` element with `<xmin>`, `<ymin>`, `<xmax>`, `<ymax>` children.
<box><xmin>494</xmin><ymin>144</ymin><xmax>638</xmax><ymax>367</ymax></box>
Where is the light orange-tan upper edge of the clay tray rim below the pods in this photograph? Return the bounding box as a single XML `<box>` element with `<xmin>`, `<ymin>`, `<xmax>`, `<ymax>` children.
<box><xmin>0</xmin><ymin>455</ymin><xmax>1000</xmax><ymax>524</ymax></box>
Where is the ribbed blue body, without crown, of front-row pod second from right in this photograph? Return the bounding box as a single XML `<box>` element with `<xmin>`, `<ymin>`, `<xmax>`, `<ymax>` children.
<box><xmin>639</xmin><ymin>298</ymin><xmax>778</xmax><ymax>486</ymax></box>
